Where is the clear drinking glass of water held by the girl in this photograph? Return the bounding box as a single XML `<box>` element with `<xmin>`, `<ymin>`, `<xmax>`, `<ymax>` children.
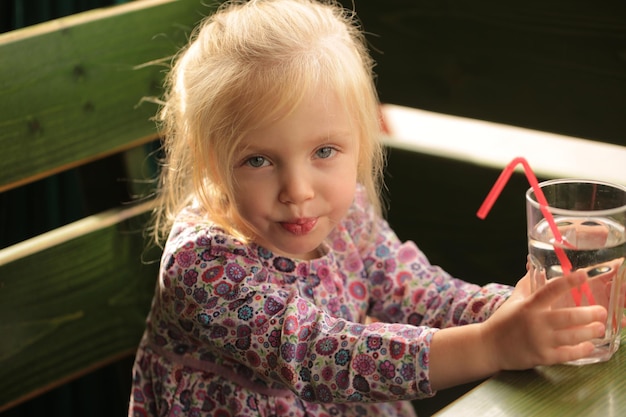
<box><xmin>526</xmin><ymin>179</ymin><xmax>626</xmax><ymax>365</ymax></box>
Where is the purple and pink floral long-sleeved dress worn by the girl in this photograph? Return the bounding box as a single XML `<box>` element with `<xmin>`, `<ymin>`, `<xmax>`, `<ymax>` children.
<box><xmin>129</xmin><ymin>189</ymin><xmax>511</xmax><ymax>417</ymax></box>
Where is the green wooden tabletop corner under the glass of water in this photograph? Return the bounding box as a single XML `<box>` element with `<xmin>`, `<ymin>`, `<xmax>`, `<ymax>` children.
<box><xmin>436</xmin><ymin>330</ymin><xmax>626</xmax><ymax>417</ymax></box>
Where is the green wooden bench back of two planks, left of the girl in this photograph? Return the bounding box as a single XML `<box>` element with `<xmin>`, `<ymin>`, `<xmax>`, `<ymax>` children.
<box><xmin>0</xmin><ymin>0</ymin><xmax>209</xmax><ymax>411</ymax></box>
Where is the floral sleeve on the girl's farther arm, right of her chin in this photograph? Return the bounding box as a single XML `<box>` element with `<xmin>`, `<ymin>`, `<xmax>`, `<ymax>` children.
<box><xmin>344</xmin><ymin>186</ymin><xmax>512</xmax><ymax>328</ymax></box>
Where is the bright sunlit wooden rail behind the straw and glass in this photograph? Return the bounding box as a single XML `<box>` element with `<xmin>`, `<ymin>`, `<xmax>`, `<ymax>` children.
<box><xmin>382</xmin><ymin>104</ymin><xmax>626</xmax><ymax>184</ymax></box>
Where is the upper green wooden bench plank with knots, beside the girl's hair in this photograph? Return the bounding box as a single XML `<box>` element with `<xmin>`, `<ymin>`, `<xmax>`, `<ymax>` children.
<box><xmin>0</xmin><ymin>0</ymin><xmax>210</xmax><ymax>191</ymax></box>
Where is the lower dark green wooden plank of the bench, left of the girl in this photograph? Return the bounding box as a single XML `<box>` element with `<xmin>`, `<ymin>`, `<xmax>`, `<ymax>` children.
<box><xmin>0</xmin><ymin>206</ymin><xmax>159</xmax><ymax>411</ymax></box>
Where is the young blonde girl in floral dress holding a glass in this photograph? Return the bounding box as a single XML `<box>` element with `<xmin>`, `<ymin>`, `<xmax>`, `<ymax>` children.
<box><xmin>129</xmin><ymin>0</ymin><xmax>606</xmax><ymax>417</ymax></box>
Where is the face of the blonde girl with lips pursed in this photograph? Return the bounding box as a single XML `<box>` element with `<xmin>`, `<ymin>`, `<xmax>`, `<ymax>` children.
<box><xmin>234</xmin><ymin>89</ymin><xmax>359</xmax><ymax>259</ymax></box>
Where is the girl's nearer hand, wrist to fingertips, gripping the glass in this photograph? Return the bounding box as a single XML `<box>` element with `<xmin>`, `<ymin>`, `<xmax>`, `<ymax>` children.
<box><xmin>482</xmin><ymin>271</ymin><xmax>607</xmax><ymax>370</ymax></box>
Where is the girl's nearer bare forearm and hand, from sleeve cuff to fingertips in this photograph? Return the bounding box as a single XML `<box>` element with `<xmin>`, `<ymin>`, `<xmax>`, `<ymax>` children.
<box><xmin>430</xmin><ymin>272</ymin><xmax>607</xmax><ymax>390</ymax></box>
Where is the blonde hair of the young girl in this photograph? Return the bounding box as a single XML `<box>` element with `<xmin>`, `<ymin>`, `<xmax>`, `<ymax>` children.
<box><xmin>153</xmin><ymin>0</ymin><xmax>384</xmax><ymax>243</ymax></box>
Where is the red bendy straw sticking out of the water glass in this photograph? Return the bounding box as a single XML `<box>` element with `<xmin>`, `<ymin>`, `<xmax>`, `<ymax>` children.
<box><xmin>476</xmin><ymin>156</ymin><xmax>595</xmax><ymax>306</ymax></box>
